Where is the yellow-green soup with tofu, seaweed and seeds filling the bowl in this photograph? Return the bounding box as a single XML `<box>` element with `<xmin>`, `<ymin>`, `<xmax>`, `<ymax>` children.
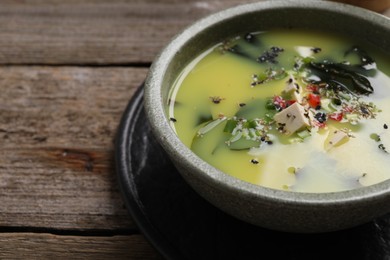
<box><xmin>167</xmin><ymin>29</ymin><xmax>390</xmax><ymax>192</ymax></box>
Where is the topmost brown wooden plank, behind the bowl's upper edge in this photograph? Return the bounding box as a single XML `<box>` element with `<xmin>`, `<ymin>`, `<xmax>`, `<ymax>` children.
<box><xmin>0</xmin><ymin>0</ymin><xmax>262</xmax><ymax>64</ymax></box>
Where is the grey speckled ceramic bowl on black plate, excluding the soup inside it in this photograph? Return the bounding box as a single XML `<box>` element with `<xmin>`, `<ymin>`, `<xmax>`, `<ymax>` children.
<box><xmin>144</xmin><ymin>0</ymin><xmax>390</xmax><ymax>233</ymax></box>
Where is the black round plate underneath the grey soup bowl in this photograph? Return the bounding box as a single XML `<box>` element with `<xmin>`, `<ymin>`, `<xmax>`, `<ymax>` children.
<box><xmin>115</xmin><ymin>86</ymin><xmax>390</xmax><ymax>260</ymax></box>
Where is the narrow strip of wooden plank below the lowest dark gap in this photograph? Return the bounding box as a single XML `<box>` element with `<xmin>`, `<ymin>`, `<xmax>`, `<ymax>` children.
<box><xmin>0</xmin><ymin>233</ymin><xmax>163</xmax><ymax>260</ymax></box>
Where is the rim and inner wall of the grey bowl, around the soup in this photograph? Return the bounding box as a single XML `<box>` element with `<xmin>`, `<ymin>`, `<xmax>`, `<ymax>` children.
<box><xmin>145</xmin><ymin>1</ymin><xmax>390</xmax><ymax>204</ymax></box>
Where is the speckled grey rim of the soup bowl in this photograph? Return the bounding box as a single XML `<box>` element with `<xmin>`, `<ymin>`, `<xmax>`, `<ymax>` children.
<box><xmin>144</xmin><ymin>0</ymin><xmax>390</xmax><ymax>206</ymax></box>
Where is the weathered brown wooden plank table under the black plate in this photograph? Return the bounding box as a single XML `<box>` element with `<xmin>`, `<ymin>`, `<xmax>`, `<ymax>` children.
<box><xmin>0</xmin><ymin>0</ymin><xmax>388</xmax><ymax>259</ymax></box>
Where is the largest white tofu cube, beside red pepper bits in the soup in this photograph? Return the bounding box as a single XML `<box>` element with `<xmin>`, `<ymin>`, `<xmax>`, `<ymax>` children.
<box><xmin>274</xmin><ymin>102</ymin><xmax>310</xmax><ymax>135</ymax></box>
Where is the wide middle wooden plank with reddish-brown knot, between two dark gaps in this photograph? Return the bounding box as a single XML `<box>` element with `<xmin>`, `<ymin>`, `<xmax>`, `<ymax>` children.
<box><xmin>0</xmin><ymin>66</ymin><xmax>147</xmax><ymax>230</ymax></box>
